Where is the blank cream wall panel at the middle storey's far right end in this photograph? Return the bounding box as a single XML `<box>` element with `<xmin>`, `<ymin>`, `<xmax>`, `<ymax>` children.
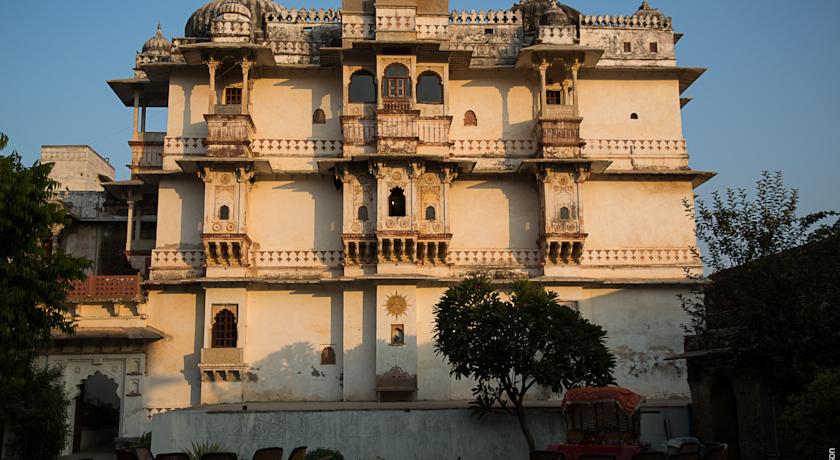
<box><xmin>581</xmin><ymin>180</ymin><xmax>696</xmax><ymax>248</ymax></box>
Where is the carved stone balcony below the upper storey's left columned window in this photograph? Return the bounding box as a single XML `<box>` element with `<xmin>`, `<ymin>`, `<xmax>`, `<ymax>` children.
<box><xmin>204</xmin><ymin>105</ymin><xmax>256</xmax><ymax>158</ymax></box>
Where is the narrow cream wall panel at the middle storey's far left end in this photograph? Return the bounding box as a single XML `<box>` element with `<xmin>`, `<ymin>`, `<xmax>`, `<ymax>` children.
<box><xmin>157</xmin><ymin>176</ymin><xmax>204</xmax><ymax>249</ymax></box>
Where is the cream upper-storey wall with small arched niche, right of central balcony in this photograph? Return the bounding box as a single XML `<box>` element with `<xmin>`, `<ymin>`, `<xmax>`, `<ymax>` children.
<box><xmin>449</xmin><ymin>69</ymin><xmax>538</xmax><ymax>139</ymax></box>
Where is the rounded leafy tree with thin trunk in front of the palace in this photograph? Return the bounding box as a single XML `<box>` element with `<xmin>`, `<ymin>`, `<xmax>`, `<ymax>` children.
<box><xmin>434</xmin><ymin>277</ymin><xmax>615</xmax><ymax>451</ymax></box>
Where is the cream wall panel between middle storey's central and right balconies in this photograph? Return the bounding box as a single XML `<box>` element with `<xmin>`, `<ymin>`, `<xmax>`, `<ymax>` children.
<box><xmin>450</xmin><ymin>176</ymin><xmax>539</xmax><ymax>249</ymax></box>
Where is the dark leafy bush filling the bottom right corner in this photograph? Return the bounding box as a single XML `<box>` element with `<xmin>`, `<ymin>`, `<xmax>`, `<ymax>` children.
<box><xmin>781</xmin><ymin>369</ymin><xmax>840</xmax><ymax>459</ymax></box>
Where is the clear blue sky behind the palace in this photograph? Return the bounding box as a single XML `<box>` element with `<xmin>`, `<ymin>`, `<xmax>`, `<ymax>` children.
<box><xmin>0</xmin><ymin>0</ymin><xmax>840</xmax><ymax>211</ymax></box>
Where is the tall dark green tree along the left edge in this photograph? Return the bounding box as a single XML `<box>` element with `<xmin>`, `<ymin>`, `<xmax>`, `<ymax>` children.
<box><xmin>0</xmin><ymin>135</ymin><xmax>89</xmax><ymax>458</ymax></box>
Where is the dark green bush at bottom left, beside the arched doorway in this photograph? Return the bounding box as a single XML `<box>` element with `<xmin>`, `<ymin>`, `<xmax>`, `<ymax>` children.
<box><xmin>4</xmin><ymin>369</ymin><xmax>70</xmax><ymax>460</ymax></box>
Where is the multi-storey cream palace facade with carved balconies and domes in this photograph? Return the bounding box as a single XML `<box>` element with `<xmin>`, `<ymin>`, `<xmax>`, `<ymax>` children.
<box><xmin>37</xmin><ymin>0</ymin><xmax>712</xmax><ymax>452</ymax></box>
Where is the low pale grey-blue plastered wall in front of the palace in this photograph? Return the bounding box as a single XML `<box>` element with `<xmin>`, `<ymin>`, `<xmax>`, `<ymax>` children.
<box><xmin>152</xmin><ymin>408</ymin><xmax>565</xmax><ymax>460</ymax></box>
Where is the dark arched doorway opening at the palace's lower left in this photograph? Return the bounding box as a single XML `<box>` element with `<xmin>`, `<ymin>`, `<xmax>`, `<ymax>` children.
<box><xmin>73</xmin><ymin>371</ymin><xmax>120</xmax><ymax>453</ymax></box>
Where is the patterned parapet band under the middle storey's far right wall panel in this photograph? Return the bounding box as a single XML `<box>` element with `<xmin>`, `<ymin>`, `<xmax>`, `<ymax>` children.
<box><xmin>581</xmin><ymin>247</ymin><xmax>700</xmax><ymax>267</ymax></box>
